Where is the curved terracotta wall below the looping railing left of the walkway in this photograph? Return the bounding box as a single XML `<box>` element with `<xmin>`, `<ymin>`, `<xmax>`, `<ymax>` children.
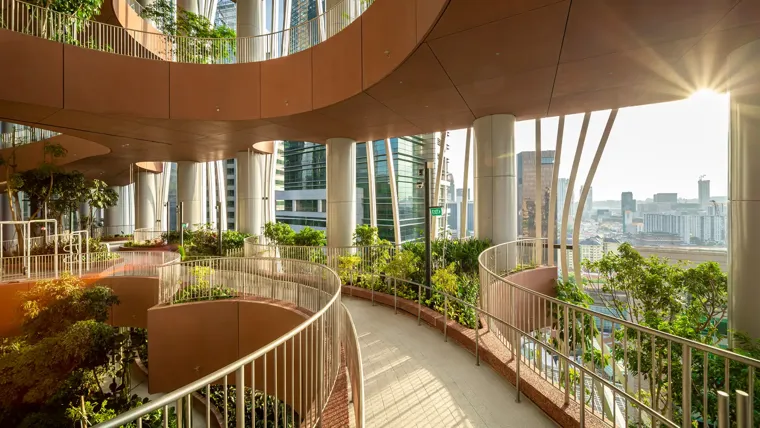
<box><xmin>148</xmin><ymin>300</ymin><xmax>313</xmax><ymax>411</ymax></box>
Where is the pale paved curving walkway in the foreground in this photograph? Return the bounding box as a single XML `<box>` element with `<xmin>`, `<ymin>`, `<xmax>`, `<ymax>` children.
<box><xmin>342</xmin><ymin>296</ymin><xmax>556</xmax><ymax>428</ymax></box>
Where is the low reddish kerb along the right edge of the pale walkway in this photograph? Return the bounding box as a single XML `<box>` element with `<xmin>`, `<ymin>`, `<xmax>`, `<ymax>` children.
<box><xmin>342</xmin><ymin>285</ymin><xmax>606</xmax><ymax>428</ymax></box>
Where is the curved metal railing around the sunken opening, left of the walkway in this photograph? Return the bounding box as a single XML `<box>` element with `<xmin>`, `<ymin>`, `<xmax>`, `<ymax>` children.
<box><xmin>97</xmin><ymin>258</ymin><xmax>364</xmax><ymax>428</ymax></box>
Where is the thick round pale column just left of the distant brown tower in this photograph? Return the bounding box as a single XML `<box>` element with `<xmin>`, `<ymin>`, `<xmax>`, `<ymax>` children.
<box><xmin>473</xmin><ymin>114</ymin><xmax>517</xmax><ymax>245</ymax></box>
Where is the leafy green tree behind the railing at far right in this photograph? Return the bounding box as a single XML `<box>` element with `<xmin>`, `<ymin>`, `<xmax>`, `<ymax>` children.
<box><xmin>560</xmin><ymin>244</ymin><xmax>760</xmax><ymax>423</ymax></box>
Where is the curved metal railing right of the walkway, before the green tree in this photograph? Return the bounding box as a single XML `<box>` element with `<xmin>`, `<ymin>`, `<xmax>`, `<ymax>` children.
<box><xmin>479</xmin><ymin>241</ymin><xmax>760</xmax><ymax>427</ymax></box>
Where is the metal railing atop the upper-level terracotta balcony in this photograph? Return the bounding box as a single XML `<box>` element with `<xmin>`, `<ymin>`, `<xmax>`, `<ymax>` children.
<box><xmin>0</xmin><ymin>0</ymin><xmax>374</xmax><ymax>64</ymax></box>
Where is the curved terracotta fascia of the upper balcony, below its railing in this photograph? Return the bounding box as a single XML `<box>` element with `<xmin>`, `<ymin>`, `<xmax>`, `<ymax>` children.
<box><xmin>0</xmin><ymin>0</ymin><xmax>447</xmax><ymax>122</ymax></box>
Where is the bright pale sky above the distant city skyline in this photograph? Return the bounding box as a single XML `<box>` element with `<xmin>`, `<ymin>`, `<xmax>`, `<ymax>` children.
<box><xmin>447</xmin><ymin>92</ymin><xmax>729</xmax><ymax>201</ymax></box>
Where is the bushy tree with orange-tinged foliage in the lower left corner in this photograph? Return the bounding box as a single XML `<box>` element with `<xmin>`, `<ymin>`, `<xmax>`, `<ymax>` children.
<box><xmin>0</xmin><ymin>275</ymin><xmax>173</xmax><ymax>428</ymax></box>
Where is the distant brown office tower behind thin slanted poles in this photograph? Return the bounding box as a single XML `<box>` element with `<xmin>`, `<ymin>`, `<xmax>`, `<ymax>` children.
<box><xmin>517</xmin><ymin>150</ymin><xmax>554</xmax><ymax>236</ymax></box>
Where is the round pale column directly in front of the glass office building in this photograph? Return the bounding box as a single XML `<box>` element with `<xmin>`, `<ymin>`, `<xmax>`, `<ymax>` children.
<box><xmin>327</xmin><ymin>138</ymin><xmax>356</xmax><ymax>247</ymax></box>
